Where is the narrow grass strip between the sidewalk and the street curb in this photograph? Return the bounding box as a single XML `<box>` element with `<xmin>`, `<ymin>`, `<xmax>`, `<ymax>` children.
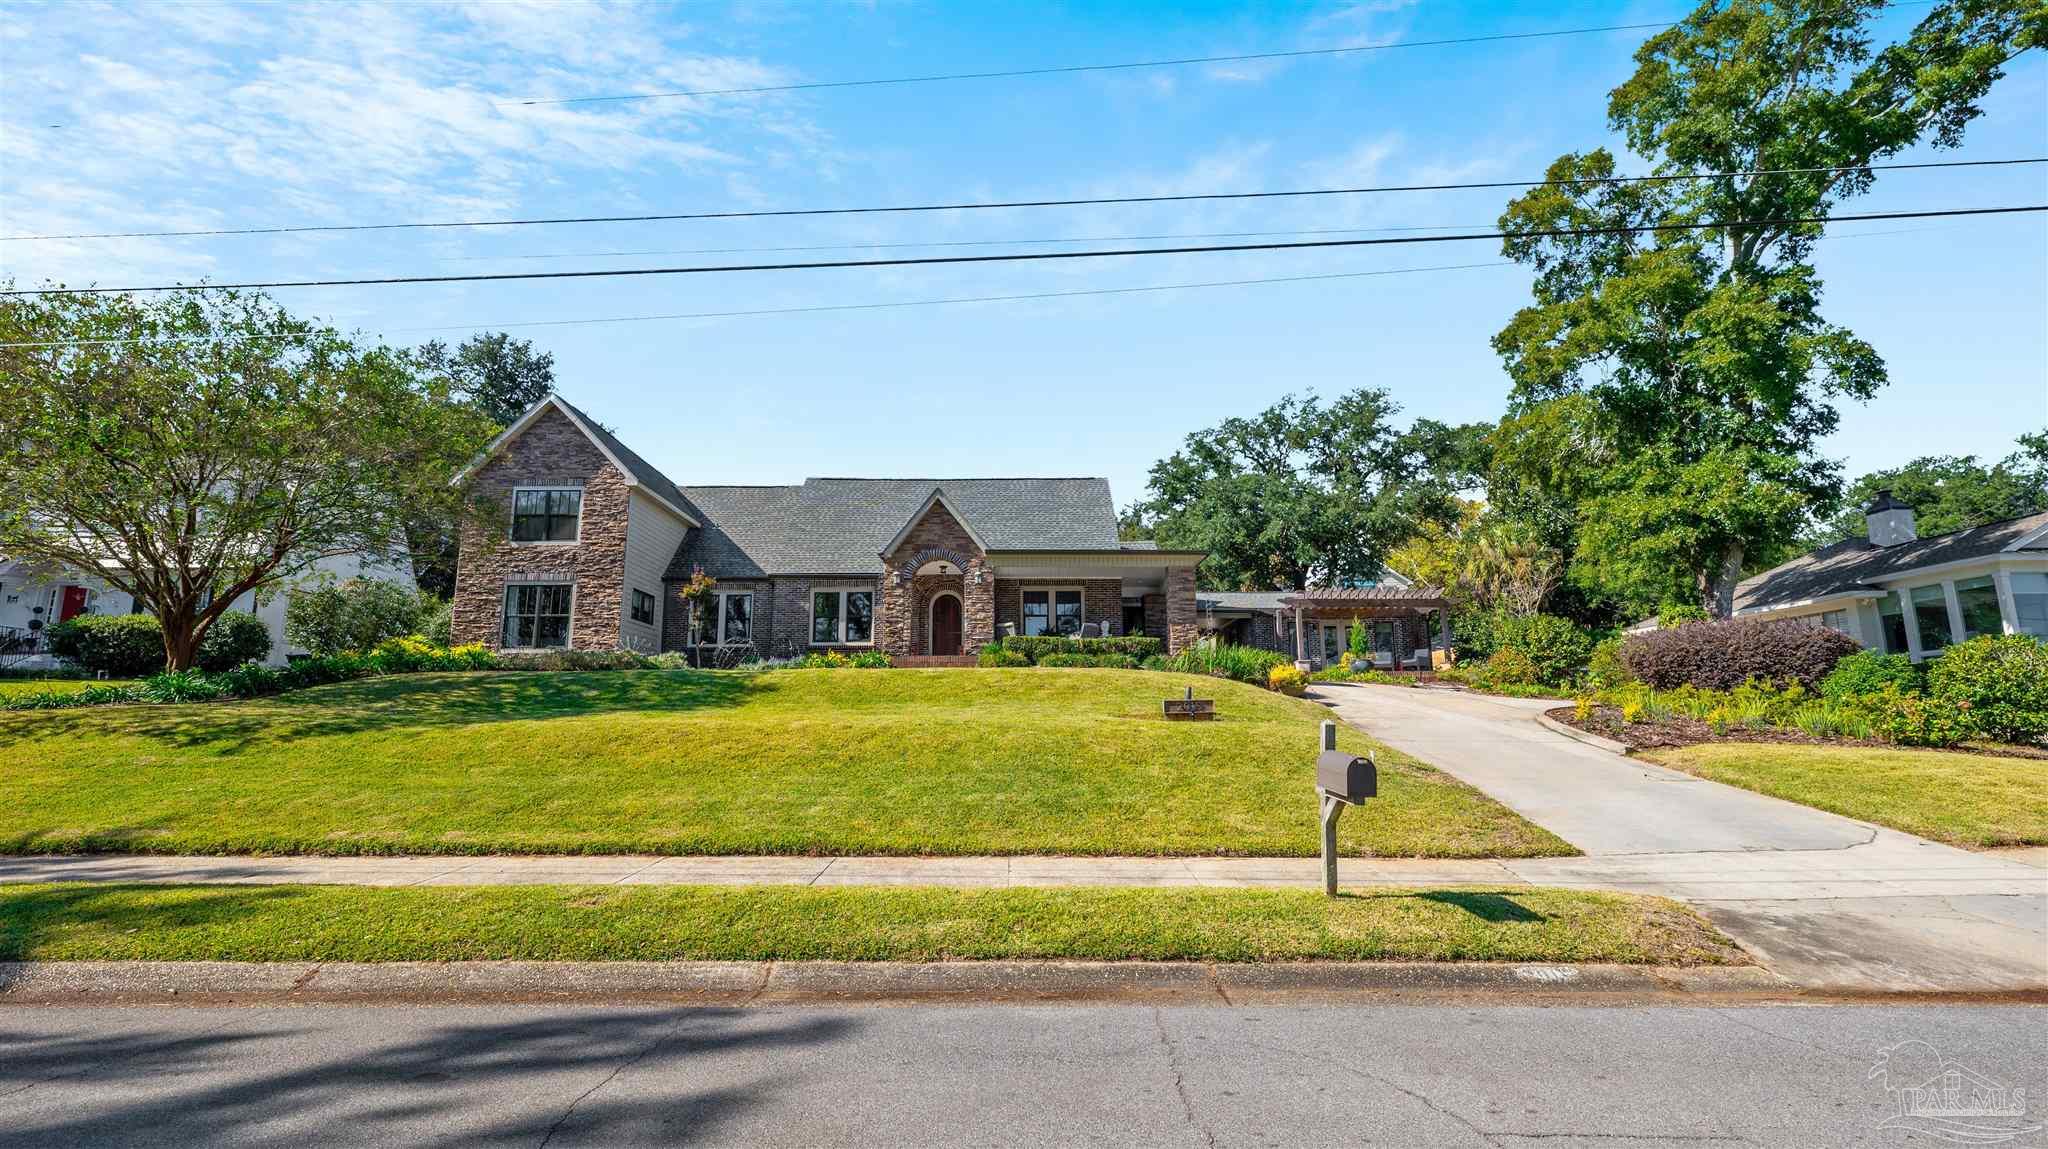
<box><xmin>0</xmin><ymin>885</ymin><xmax>1745</xmax><ymax>965</ymax></box>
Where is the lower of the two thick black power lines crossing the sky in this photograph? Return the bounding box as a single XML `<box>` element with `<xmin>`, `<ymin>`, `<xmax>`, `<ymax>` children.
<box><xmin>12</xmin><ymin>203</ymin><xmax>2048</xmax><ymax>297</ymax></box>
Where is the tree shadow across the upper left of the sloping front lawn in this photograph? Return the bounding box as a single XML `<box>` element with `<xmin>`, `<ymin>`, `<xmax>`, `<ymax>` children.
<box><xmin>0</xmin><ymin>670</ymin><xmax>772</xmax><ymax>754</ymax></box>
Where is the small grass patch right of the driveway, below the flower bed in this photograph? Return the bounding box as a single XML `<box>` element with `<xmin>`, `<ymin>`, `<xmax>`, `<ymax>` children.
<box><xmin>1647</xmin><ymin>741</ymin><xmax>2048</xmax><ymax>846</ymax></box>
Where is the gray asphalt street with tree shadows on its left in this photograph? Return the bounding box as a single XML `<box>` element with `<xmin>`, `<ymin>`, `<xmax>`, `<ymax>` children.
<box><xmin>0</xmin><ymin>1004</ymin><xmax>2048</xmax><ymax>1149</ymax></box>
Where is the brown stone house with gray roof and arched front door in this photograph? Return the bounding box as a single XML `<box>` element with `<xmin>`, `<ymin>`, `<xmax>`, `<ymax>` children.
<box><xmin>455</xmin><ymin>395</ymin><xmax>1202</xmax><ymax>662</ymax></box>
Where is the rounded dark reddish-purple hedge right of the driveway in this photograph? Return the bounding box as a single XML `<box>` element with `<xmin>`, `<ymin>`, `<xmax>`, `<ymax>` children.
<box><xmin>1622</xmin><ymin>619</ymin><xmax>1862</xmax><ymax>690</ymax></box>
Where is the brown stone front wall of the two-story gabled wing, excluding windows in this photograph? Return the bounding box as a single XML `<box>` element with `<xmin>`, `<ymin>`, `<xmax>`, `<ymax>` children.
<box><xmin>451</xmin><ymin>408</ymin><xmax>629</xmax><ymax>649</ymax></box>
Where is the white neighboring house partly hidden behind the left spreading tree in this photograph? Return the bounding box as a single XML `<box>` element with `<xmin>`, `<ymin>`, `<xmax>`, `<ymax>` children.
<box><xmin>0</xmin><ymin>555</ymin><xmax>418</xmax><ymax>670</ymax></box>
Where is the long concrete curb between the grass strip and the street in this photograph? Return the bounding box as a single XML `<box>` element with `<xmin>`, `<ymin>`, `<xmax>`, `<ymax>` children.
<box><xmin>0</xmin><ymin>961</ymin><xmax>1826</xmax><ymax>1006</ymax></box>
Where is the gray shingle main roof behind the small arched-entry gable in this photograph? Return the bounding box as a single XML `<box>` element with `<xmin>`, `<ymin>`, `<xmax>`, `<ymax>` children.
<box><xmin>668</xmin><ymin>479</ymin><xmax>1118</xmax><ymax>578</ymax></box>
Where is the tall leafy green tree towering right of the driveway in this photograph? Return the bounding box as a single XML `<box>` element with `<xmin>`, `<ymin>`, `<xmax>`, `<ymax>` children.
<box><xmin>1493</xmin><ymin>0</ymin><xmax>2048</xmax><ymax>616</ymax></box>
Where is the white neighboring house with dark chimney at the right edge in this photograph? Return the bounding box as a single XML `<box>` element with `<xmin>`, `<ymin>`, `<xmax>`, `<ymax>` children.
<box><xmin>1735</xmin><ymin>492</ymin><xmax>2048</xmax><ymax>662</ymax></box>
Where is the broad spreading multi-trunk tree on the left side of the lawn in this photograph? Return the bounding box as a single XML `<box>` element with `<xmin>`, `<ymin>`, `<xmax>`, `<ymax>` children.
<box><xmin>0</xmin><ymin>289</ymin><xmax>492</xmax><ymax>670</ymax></box>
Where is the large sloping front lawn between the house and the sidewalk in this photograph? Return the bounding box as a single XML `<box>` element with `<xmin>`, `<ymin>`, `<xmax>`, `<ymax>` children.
<box><xmin>0</xmin><ymin>670</ymin><xmax>1573</xmax><ymax>858</ymax></box>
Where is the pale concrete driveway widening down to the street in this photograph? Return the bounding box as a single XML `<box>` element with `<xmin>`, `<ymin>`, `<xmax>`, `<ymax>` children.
<box><xmin>1311</xmin><ymin>684</ymin><xmax>2048</xmax><ymax>991</ymax></box>
